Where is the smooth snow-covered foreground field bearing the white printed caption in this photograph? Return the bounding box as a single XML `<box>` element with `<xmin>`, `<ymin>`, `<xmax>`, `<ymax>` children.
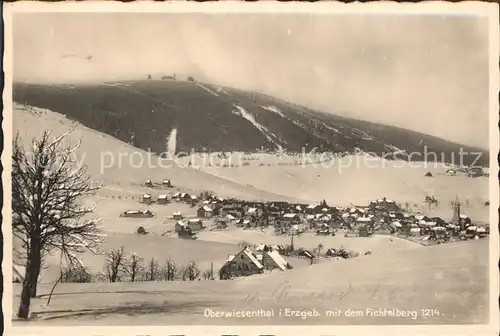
<box><xmin>14</xmin><ymin>240</ymin><xmax>488</xmax><ymax>326</ymax></box>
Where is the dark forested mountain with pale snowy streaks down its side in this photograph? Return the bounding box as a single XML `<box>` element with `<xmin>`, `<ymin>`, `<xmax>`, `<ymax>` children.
<box><xmin>13</xmin><ymin>80</ymin><xmax>489</xmax><ymax>166</ymax></box>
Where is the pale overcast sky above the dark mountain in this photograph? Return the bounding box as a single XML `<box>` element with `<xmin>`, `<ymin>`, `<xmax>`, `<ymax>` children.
<box><xmin>14</xmin><ymin>13</ymin><xmax>488</xmax><ymax>148</ymax></box>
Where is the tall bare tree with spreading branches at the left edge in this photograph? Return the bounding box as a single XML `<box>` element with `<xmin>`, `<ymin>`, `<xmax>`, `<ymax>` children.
<box><xmin>12</xmin><ymin>130</ymin><xmax>101</xmax><ymax>318</ymax></box>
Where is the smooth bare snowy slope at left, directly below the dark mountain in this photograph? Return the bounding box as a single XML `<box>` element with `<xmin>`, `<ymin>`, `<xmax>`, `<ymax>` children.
<box><xmin>13</xmin><ymin>104</ymin><xmax>302</xmax><ymax>201</ymax></box>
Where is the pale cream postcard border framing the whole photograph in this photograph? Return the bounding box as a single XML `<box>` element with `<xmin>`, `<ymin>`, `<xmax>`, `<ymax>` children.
<box><xmin>2</xmin><ymin>1</ymin><xmax>500</xmax><ymax>336</ymax></box>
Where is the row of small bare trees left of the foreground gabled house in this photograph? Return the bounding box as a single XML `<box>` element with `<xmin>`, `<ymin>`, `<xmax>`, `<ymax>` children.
<box><xmin>60</xmin><ymin>246</ymin><xmax>215</xmax><ymax>283</ymax></box>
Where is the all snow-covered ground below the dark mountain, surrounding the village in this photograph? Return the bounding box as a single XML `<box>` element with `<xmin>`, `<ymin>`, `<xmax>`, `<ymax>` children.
<box><xmin>10</xmin><ymin>106</ymin><xmax>488</xmax><ymax>325</ymax></box>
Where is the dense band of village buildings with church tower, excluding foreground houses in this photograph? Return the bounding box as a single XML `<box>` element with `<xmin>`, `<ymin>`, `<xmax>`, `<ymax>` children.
<box><xmin>133</xmin><ymin>180</ymin><xmax>489</xmax><ymax>240</ymax></box>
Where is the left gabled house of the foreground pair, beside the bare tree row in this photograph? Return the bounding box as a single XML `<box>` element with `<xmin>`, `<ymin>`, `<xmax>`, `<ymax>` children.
<box><xmin>219</xmin><ymin>247</ymin><xmax>264</xmax><ymax>280</ymax></box>
